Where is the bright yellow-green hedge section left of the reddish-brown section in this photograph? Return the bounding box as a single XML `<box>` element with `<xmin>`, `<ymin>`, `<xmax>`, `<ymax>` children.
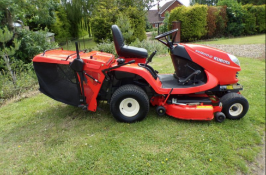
<box><xmin>168</xmin><ymin>5</ymin><xmax>208</xmax><ymax>41</ymax></box>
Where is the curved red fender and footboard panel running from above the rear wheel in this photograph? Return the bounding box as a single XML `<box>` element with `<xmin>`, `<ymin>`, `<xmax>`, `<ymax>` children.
<box><xmin>112</xmin><ymin>63</ymin><xmax>218</xmax><ymax>94</ymax></box>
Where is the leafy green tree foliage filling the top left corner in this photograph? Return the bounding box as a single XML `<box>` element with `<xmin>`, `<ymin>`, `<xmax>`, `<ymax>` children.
<box><xmin>0</xmin><ymin>0</ymin><xmax>59</xmax><ymax>30</ymax></box>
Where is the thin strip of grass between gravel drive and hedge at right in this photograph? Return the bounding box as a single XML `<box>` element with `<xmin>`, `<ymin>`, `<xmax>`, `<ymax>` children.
<box><xmin>196</xmin><ymin>34</ymin><xmax>265</xmax><ymax>44</ymax></box>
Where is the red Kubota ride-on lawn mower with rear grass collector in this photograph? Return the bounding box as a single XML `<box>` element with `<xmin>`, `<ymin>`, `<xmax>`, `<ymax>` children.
<box><xmin>33</xmin><ymin>25</ymin><xmax>249</xmax><ymax>123</ymax></box>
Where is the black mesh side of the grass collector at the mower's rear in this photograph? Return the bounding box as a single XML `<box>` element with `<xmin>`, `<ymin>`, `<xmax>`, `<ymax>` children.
<box><xmin>33</xmin><ymin>62</ymin><xmax>80</xmax><ymax>106</ymax></box>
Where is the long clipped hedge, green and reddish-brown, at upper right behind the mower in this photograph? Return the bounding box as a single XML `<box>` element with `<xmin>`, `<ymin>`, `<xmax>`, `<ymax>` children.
<box><xmin>168</xmin><ymin>0</ymin><xmax>266</xmax><ymax>41</ymax></box>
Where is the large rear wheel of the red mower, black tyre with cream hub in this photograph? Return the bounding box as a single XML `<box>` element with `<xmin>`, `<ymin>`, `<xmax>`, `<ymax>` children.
<box><xmin>110</xmin><ymin>84</ymin><xmax>150</xmax><ymax>123</ymax></box>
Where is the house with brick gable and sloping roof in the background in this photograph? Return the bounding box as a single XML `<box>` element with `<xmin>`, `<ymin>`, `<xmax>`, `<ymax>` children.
<box><xmin>148</xmin><ymin>0</ymin><xmax>183</xmax><ymax>27</ymax></box>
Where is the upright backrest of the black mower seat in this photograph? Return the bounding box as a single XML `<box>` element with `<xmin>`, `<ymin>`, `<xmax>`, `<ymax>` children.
<box><xmin>112</xmin><ymin>25</ymin><xmax>124</xmax><ymax>55</ymax></box>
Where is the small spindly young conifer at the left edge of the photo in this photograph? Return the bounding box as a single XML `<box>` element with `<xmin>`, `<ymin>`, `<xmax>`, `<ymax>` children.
<box><xmin>0</xmin><ymin>27</ymin><xmax>20</xmax><ymax>87</ymax></box>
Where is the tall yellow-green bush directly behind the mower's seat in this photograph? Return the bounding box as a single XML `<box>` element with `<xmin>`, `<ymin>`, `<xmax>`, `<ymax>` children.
<box><xmin>91</xmin><ymin>0</ymin><xmax>150</xmax><ymax>42</ymax></box>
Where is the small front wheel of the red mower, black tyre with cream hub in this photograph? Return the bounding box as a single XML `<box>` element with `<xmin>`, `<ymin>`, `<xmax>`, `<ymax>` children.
<box><xmin>220</xmin><ymin>92</ymin><xmax>249</xmax><ymax>120</ymax></box>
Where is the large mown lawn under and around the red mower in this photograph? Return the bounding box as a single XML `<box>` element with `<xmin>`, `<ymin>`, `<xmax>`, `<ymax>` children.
<box><xmin>0</xmin><ymin>35</ymin><xmax>265</xmax><ymax>174</ymax></box>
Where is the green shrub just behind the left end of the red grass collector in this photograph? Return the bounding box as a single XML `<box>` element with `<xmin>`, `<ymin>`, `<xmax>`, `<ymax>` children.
<box><xmin>14</xmin><ymin>29</ymin><xmax>57</xmax><ymax>63</ymax></box>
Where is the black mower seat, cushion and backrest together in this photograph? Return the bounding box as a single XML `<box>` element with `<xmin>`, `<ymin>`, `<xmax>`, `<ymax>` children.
<box><xmin>112</xmin><ymin>25</ymin><xmax>148</xmax><ymax>58</ymax></box>
